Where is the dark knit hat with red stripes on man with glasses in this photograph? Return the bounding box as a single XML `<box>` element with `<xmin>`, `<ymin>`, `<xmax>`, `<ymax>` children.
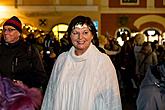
<box><xmin>3</xmin><ymin>16</ymin><xmax>22</xmax><ymax>33</ymax></box>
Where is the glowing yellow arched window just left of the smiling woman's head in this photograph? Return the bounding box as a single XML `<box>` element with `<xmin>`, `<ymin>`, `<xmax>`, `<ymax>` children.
<box><xmin>52</xmin><ymin>24</ymin><xmax>68</xmax><ymax>41</ymax></box>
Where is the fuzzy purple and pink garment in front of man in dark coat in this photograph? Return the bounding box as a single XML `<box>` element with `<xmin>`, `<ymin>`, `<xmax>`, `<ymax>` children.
<box><xmin>0</xmin><ymin>76</ymin><xmax>43</xmax><ymax>110</ymax></box>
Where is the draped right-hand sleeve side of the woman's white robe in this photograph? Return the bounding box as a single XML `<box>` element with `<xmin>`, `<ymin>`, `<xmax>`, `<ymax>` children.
<box><xmin>96</xmin><ymin>57</ymin><xmax>122</xmax><ymax>110</ymax></box>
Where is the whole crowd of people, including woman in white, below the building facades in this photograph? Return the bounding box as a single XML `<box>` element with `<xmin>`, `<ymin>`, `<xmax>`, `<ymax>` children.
<box><xmin>0</xmin><ymin>16</ymin><xmax>165</xmax><ymax>110</ymax></box>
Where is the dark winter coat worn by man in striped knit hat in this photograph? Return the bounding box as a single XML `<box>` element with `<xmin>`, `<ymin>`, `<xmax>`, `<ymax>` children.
<box><xmin>0</xmin><ymin>40</ymin><xmax>46</xmax><ymax>87</ymax></box>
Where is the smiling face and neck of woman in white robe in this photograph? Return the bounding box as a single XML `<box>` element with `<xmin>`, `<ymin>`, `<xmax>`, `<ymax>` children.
<box><xmin>70</xmin><ymin>24</ymin><xmax>93</xmax><ymax>55</ymax></box>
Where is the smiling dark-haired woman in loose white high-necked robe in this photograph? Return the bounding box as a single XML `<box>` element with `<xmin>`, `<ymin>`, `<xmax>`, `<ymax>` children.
<box><xmin>41</xmin><ymin>16</ymin><xmax>122</xmax><ymax>110</ymax></box>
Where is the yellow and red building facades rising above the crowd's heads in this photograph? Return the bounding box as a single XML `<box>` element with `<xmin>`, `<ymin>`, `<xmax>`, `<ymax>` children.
<box><xmin>0</xmin><ymin>0</ymin><xmax>165</xmax><ymax>41</ymax></box>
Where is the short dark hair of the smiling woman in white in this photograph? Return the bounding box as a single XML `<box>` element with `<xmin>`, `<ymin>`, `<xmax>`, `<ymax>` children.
<box><xmin>67</xmin><ymin>16</ymin><xmax>97</xmax><ymax>44</ymax></box>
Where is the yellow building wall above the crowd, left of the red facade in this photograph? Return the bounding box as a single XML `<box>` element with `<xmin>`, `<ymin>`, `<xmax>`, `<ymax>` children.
<box><xmin>0</xmin><ymin>0</ymin><xmax>100</xmax><ymax>34</ymax></box>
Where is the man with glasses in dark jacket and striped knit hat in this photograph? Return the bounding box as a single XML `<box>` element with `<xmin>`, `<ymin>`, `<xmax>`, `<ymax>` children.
<box><xmin>0</xmin><ymin>16</ymin><xmax>47</xmax><ymax>88</ymax></box>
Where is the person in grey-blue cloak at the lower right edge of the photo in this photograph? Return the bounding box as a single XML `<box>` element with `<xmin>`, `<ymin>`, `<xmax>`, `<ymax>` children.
<box><xmin>136</xmin><ymin>55</ymin><xmax>165</xmax><ymax>110</ymax></box>
